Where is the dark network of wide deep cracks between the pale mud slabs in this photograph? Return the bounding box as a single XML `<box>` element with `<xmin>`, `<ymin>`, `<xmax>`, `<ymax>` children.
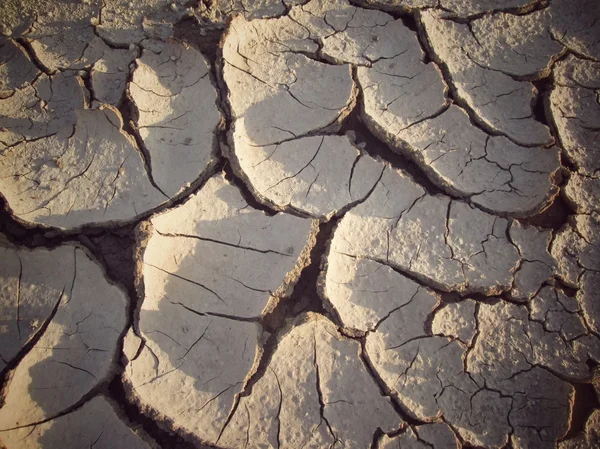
<box><xmin>0</xmin><ymin>0</ymin><xmax>600</xmax><ymax>449</ymax></box>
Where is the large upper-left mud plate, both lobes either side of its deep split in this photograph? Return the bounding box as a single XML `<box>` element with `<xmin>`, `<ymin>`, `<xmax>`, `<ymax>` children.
<box><xmin>0</xmin><ymin>41</ymin><xmax>220</xmax><ymax>230</ymax></box>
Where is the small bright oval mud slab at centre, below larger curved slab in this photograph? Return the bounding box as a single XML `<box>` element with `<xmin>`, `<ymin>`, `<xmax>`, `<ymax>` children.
<box><xmin>227</xmin><ymin>135</ymin><xmax>383</xmax><ymax>217</ymax></box>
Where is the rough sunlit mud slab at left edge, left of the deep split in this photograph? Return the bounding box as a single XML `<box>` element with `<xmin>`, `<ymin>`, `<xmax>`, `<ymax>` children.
<box><xmin>0</xmin><ymin>106</ymin><xmax>168</xmax><ymax>229</ymax></box>
